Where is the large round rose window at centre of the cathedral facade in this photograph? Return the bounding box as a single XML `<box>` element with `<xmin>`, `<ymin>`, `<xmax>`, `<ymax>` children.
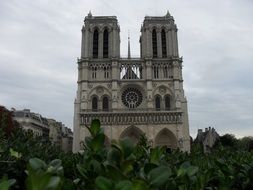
<box><xmin>121</xmin><ymin>88</ymin><xmax>142</xmax><ymax>108</ymax></box>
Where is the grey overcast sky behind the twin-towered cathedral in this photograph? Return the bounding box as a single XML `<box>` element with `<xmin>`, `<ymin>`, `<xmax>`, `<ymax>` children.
<box><xmin>0</xmin><ymin>0</ymin><xmax>253</xmax><ymax>138</ymax></box>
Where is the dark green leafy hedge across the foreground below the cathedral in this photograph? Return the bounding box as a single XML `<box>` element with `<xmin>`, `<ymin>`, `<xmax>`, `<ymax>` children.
<box><xmin>0</xmin><ymin>116</ymin><xmax>253</xmax><ymax>190</ymax></box>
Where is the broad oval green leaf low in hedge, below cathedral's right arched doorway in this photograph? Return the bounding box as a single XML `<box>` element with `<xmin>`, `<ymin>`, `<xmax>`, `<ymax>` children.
<box><xmin>148</xmin><ymin>166</ymin><xmax>171</xmax><ymax>187</ymax></box>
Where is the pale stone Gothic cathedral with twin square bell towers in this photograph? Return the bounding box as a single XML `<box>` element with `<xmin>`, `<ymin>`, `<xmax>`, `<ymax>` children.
<box><xmin>73</xmin><ymin>13</ymin><xmax>190</xmax><ymax>152</ymax></box>
